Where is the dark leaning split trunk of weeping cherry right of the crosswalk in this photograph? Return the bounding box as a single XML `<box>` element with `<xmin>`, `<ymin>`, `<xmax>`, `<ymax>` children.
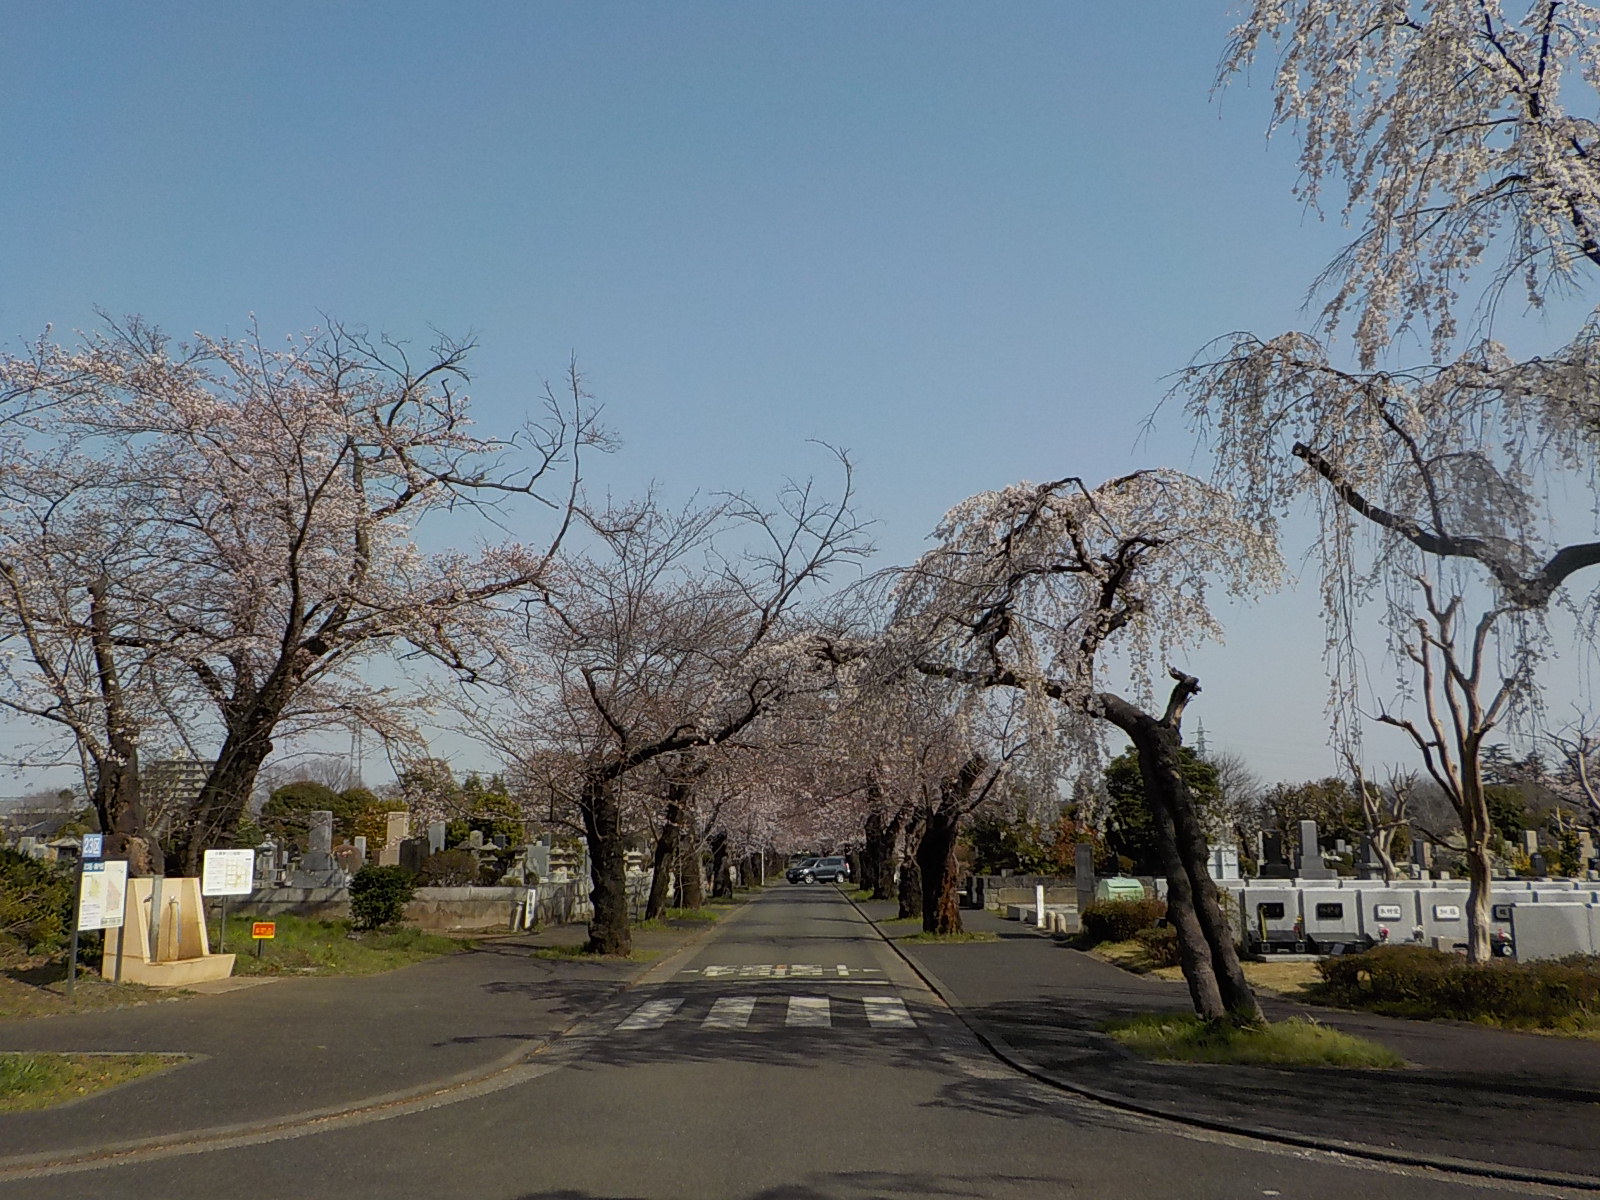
<box><xmin>1099</xmin><ymin>691</ymin><xmax>1266</xmax><ymax>1026</ymax></box>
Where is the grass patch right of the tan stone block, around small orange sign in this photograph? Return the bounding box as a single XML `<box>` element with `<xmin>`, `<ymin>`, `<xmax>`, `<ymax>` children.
<box><xmin>225</xmin><ymin>915</ymin><xmax>474</xmax><ymax>976</ymax></box>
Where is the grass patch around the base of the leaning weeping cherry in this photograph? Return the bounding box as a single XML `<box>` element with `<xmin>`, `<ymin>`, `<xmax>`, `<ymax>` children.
<box><xmin>1101</xmin><ymin>1013</ymin><xmax>1405</xmax><ymax>1070</ymax></box>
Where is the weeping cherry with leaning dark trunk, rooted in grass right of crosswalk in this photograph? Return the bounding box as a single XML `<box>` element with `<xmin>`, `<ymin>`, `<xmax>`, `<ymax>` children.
<box><xmin>885</xmin><ymin>470</ymin><xmax>1278</xmax><ymax>1022</ymax></box>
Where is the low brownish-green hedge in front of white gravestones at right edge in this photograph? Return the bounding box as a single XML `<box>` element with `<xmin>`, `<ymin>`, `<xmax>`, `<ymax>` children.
<box><xmin>1317</xmin><ymin>946</ymin><xmax>1600</xmax><ymax>1029</ymax></box>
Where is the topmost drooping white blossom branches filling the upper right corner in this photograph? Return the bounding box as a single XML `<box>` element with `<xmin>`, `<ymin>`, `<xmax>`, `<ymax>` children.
<box><xmin>1222</xmin><ymin>0</ymin><xmax>1600</xmax><ymax>370</ymax></box>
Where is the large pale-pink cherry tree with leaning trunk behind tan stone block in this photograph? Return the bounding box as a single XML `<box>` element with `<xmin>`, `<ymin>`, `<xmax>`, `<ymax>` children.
<box><xmin>0</xmin><ymin>320</ymin><xmax>603</xmax><ymax>874</ymax></box>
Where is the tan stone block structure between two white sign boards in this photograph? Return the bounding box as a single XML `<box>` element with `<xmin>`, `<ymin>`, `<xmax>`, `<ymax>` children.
<box><xmin>101</xmin><ymin>878</ymin><xmax>234</xmax><ymax>987</ymax></box>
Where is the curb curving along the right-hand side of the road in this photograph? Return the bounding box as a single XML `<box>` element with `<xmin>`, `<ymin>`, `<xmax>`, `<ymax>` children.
<box><xmin>846</xmin><ymin>894</ymin><xmax>1600</xmax><ymax>1192</ymax></box>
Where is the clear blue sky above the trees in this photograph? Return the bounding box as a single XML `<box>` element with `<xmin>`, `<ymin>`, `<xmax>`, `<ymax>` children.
<box><xmin>0</xmin><ymin>0</ymin><xmax>1497</xmax><ymax>792</ymax></box>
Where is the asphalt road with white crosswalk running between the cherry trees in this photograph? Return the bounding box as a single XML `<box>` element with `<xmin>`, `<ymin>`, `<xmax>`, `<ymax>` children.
<box><xmin>0</xmin><ymin>886</ymin><xmax>1561</xmax><ymax>1200</ymax></box>
